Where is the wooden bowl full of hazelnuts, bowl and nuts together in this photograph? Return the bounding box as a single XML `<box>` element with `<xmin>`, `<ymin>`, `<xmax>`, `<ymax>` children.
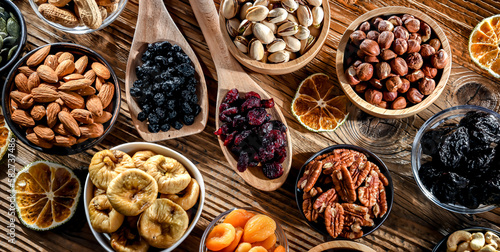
<box><xmin>336</xmin><ymin>6</ymin><xmax>451</xmax><ymax>118</ymax></box>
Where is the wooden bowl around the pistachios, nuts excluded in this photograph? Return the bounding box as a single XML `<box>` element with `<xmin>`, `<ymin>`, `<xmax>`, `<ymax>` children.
<box><xmin>219</xmin><ymin>0</ymin><xmax>330</xmax><ymax>75</ymax></box>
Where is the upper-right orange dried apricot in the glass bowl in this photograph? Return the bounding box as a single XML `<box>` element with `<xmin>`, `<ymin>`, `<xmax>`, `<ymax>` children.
<box><xmin>243</xmin><ymin>214</ymin><xmax>276</xmax><ymax>243</ymax></box>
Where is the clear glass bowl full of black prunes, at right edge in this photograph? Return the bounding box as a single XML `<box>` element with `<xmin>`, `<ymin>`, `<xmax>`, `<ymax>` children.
<box><xmin>411</xmin><ymin>105</ymin><xmax>500</xmax><ymax>214</ymax></box>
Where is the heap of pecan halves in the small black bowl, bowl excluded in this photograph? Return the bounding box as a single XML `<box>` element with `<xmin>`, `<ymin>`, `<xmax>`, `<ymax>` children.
<box><xmin>297</xmin><ymin>149</ymin><xmax>389</xmax><ymax>239</ymax></box>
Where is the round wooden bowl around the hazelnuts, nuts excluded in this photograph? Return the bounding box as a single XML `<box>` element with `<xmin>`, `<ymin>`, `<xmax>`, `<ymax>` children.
<box><xmin>336</xmin><ymin>6</ymin><xmax>452</xmax><ymax>118</ymax></box>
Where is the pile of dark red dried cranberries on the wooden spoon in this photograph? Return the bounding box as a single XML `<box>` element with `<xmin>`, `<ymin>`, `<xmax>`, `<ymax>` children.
<box><xmin>215</xmin><ymin>89</ymin><xmax>287</xmax><ymax>179</ymax></box>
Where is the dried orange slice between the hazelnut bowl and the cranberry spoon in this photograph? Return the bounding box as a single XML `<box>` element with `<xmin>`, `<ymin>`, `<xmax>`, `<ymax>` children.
<box><xmin>292</xmin><ymin>73</ymin><xmax>349</xmax><ymax>132</ymax></box>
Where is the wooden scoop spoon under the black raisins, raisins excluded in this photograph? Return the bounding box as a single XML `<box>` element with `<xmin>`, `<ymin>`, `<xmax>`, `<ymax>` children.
<box><xmin>125</xmin><ymin>0</ymin><xmax>208</xmax><ymax>142</ymax></box>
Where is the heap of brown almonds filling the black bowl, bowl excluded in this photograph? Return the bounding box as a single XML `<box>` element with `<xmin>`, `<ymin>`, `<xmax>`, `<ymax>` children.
<box><xmin>9</xmin><ymin>45</ymin><xmax>115</xmax><ymax>149</ymax></box>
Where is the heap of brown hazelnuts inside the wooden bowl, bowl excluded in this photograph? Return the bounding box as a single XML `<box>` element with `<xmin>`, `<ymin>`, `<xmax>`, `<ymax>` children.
<box><xmin>344</xmin><ymin>14</ymin><xmax>450</xmax><ymax>109</ymax></box>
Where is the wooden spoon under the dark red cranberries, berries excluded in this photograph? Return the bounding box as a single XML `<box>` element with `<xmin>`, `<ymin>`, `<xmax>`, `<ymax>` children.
<box><xmin>189</xmin><ymin>0</ymin><xmax>292</xmax><ymax>191</ymax></box>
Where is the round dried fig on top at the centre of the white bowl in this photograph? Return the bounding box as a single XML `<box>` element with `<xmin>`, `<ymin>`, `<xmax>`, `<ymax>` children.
<box><xmin>106</xmin><ymin>169</ymin><xmax>158</xmax><ymax>216</ymax></box>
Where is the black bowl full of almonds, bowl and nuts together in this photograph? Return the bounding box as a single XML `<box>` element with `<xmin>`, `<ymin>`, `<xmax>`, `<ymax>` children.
<box><xmin>2</xmin><ymin>43</ymin><xmax>120</xmax><ymax>155</ymax></box>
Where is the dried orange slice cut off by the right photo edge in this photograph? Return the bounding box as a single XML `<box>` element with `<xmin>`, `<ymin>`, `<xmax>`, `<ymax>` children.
<box><xmin>469</xmin><ymin>15</ymin><xmax>500</xmax><ymax>78</ymax></box>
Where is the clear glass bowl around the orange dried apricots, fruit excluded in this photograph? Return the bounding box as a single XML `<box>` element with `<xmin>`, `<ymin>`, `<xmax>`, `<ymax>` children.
<box><xmin>199</xmin><ymin>207</ymin><xmax>288</xmax><ymax>252</ymax></box>
